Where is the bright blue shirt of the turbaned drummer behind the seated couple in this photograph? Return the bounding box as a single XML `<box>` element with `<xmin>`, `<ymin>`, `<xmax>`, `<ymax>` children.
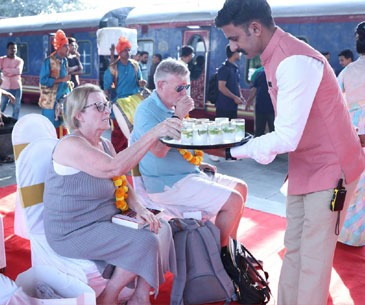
<box><xmin>104</xmin><ymin>61</ymin><xmax>142</xmax><ymax>98</ymax></box>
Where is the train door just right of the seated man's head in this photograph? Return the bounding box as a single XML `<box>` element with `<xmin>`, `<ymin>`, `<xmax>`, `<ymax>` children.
<box><xmin>183</xmin><ymin>29</ymin><xmax>209</xmax><ymax>110</ymax></box>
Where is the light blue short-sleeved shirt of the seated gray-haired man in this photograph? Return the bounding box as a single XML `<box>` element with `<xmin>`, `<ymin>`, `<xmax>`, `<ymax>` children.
<box><xmin>131</xmin><ymin>91</ymin><xmax>199</xmax><ymax>193</ymax></box>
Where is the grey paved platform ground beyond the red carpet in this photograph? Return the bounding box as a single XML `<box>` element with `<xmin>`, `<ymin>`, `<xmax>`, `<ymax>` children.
<box><xmin>0</xmin><ymin>104</ymin><xmax>288</xmax><ymax>216</ymax></box>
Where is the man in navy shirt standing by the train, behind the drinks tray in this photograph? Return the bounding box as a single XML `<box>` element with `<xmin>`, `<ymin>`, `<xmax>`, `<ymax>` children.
<box><xmin>215</xmin><ymin>45</ymin><xmax>245</xmax><ymax>119</ymax></box>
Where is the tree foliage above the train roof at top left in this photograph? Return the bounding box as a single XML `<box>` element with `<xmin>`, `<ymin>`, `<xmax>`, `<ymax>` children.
<box><xmin>0</xmin><ymin>0</ymin><xmax>85</xmax><ymax>17</ymax></box>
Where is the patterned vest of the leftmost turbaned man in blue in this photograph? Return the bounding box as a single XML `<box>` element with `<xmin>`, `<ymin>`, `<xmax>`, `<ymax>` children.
<box><xmin>38</xmin><ymin>54</ymin><xmax>68</xmax><ymax>109</ymax></box>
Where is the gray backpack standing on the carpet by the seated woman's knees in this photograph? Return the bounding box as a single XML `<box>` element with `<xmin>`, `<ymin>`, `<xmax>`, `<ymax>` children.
<box><xmin>169</xmin><ymin>218</ymin><xmax>234</xmax><ymax>305</ymax></box>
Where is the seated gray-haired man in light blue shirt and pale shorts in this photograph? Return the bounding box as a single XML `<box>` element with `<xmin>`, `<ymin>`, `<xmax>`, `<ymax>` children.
<box><xmin>131</xmin><ymin>58</ymin><xmax>247</xmax><ymax>247</ymax></box>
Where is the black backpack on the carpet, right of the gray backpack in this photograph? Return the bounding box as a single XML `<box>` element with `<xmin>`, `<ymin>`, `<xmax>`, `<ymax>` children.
<box><xmin>221</xmin><ymin>239</ymin><xmax>271</xmax><ymax>305</ymax></box>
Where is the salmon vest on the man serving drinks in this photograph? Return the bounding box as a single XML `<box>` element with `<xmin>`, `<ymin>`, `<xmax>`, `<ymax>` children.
<box><xmin>261</xmin><ymin>28</ymin><xmax>365</xmax><ymax>195</ymax></box>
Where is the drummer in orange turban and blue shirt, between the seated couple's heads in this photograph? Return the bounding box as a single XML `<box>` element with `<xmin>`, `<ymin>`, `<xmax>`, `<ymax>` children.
<box><xmin>104</xmin><ymin>36</ymin><xmax>147</xmax><ymax>152</ymax></box>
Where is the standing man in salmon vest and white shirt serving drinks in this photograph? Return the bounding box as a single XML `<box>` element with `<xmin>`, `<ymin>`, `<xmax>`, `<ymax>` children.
<box><xmin>212</xmin><ymin>0</ymin><xmax>365</xmax><ymax>305</ymax></box>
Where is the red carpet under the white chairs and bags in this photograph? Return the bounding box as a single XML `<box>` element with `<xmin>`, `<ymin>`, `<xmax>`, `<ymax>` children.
<box><xmin>0</xmin><ymin>185</ymin><xmax>365</xmax><ymax>305</ymax></box>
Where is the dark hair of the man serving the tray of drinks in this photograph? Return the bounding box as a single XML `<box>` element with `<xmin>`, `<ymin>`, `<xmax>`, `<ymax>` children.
<box><xmin>215</xmin><ymin>0</ymin><xmax>275</xmax><ymax>28</ymax></box>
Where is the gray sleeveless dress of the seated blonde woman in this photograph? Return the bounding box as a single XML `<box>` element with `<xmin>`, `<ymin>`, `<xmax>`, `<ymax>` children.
<box><xmin>44</xmin><ymin>137</ymin><xmax>176</xmax><ymax>291</ymax></box>
